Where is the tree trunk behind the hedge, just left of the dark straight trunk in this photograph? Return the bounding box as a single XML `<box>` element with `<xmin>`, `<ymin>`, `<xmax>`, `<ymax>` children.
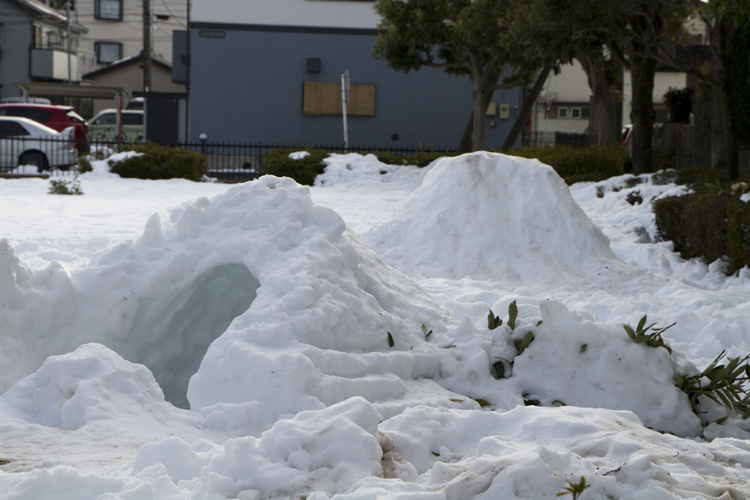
<box><xmin>577</xmin><ymin>55</ymin><xmax>621</xmax><ymax>144</ymax></box>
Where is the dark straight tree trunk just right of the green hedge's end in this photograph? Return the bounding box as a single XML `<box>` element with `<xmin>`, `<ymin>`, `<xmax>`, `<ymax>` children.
<box><xmin>630</xmin><ymin>56</ymin><xmax>656</xmax><ymax>175</ymax></box>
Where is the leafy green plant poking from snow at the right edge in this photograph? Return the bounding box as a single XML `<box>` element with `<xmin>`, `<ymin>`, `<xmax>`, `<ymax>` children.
<box><xmin>675</xmin><ymin>351</ymin><xmax>750</xmax><ymax>424</ymax></box>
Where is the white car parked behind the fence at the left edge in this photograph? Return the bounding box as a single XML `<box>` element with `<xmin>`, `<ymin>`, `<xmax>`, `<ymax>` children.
<box><xmin>0</xmin><ymin>116</ymin><xmax>76</xmax><ymax>172</ymax></box>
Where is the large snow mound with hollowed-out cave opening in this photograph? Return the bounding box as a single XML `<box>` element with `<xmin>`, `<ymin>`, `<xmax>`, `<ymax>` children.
<box><xmin>0</xmin><ymin>176</ymin><xmax>472</xmax><ymax>416</ymax></box>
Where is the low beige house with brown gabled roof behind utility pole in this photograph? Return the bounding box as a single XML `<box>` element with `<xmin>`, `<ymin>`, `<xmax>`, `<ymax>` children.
<box><xmin>83</xmin><ymin>54</ymin><xmax>185</xmax><ymax>114</ymax></box>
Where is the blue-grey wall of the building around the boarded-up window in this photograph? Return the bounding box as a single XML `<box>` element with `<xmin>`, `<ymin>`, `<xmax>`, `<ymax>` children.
<box><xmin>188</xmin><ymin>24</ymin><xmax>520</xmax><ymax>148</ymax></box>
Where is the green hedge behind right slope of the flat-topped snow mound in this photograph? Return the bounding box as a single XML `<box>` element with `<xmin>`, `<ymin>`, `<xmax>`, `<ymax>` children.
<box><xmin>508</xmin><ymin>144</ymin><xmax>630</xmax><ymax>184</ymax></box>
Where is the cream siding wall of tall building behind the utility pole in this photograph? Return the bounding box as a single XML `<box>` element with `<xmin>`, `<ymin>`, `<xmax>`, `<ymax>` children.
<box><xmin>75</xmin><ymin>0</ymin><xmax>187</xmax><ymax>67</ymax></box>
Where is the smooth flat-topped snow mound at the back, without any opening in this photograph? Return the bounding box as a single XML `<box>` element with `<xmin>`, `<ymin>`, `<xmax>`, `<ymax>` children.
<box><xmin>362</xmin><ymin>152</ymin><xmax>622</xmax><ymax>286</ymax></box>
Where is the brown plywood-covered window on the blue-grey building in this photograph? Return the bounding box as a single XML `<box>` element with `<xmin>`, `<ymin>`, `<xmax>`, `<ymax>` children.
<box><xmin>302</xmin><ymin>82</ymin><xmax>375</xmax><ymax>116</ymax></box>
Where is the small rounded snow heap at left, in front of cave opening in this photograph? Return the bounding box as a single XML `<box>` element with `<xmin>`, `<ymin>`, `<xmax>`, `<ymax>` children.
<box><xmin>0</xmin><ymin>344</ymin><xmax>164</xmax><ymax>430</ymax></box>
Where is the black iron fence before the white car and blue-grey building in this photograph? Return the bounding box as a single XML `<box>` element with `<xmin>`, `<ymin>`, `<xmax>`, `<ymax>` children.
<box><xmin>0</xmin><ymin>137</ymin><xmax>455</xmax><ymax>182</ymax></box>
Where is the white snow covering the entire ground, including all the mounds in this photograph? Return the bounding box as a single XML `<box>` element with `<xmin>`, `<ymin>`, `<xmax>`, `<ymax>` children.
<box><xmin>0</xmin><ymin>153</ymin><xmax>750</xmax><ymax>500</ymax></box>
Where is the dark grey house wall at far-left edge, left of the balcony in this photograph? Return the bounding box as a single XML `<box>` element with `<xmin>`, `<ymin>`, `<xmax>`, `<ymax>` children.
<box><xmin>0</xmin><ymin>0</ymin><xmax>34</xmax><ymax>98</ymax></box>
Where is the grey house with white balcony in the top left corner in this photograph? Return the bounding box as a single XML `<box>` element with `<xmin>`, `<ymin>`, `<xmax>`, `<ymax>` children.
<box><xmin>0</xmin><ymin>0</ymin><xmax>87</xmax><ymax>98</ymax></box>
